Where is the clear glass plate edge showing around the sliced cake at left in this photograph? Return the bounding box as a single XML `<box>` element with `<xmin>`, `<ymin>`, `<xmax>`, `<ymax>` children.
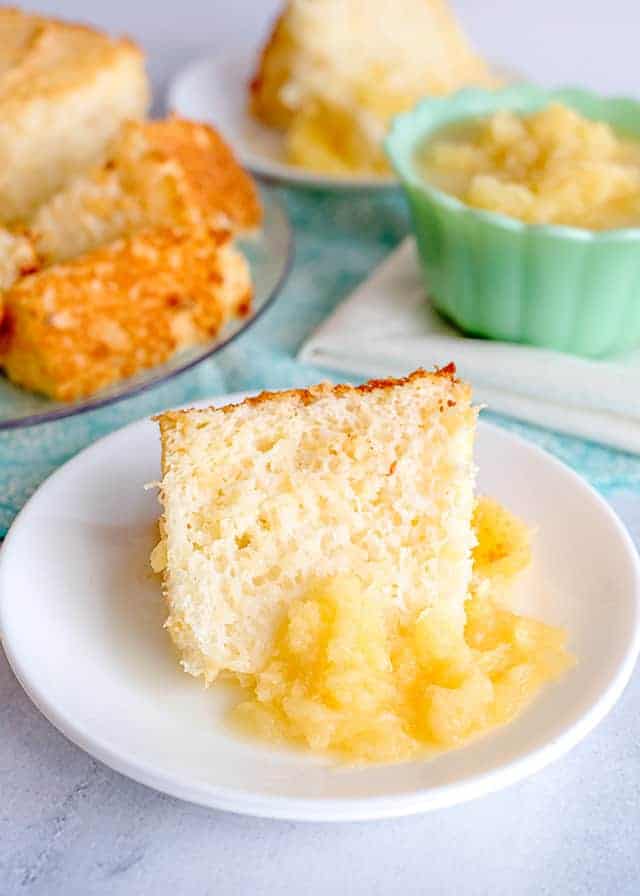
<box><xmin>0</xmin><ymin>187</ymin><xmax>293</xmax><ymax>430</ymax></box>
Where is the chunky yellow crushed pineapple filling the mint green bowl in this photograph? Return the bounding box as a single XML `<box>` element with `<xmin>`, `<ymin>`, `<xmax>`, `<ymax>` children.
<box><xmin>419</xmin><ymin>103</ymin><xmax>640</xmax><ymax>230</ymax></box>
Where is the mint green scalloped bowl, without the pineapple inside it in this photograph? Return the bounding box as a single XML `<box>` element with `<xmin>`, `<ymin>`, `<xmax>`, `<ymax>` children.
<box><xmin>385</xmin><ymin>84</ymin><xmax>640</xmax><ymax>357</ymax></box>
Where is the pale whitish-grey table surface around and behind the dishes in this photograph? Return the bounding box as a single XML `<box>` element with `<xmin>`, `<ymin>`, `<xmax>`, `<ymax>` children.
<box><xmin>0</xmin><ymin>0</ymin><xmax>640</xmax><ymax>896</ymax></box>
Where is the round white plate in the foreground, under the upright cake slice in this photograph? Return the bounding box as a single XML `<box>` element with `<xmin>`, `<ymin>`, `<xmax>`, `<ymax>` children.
<box><xmin>0</xmin><ymin>396</ymin><xmax>640</xmax><ymax>820</ymax></box>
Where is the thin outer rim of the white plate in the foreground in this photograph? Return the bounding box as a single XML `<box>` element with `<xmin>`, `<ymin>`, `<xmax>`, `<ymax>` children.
<box><xmin>0</xmin><ymin>393</ymin><xmax>640</xmax><ymax>821</ymax></box>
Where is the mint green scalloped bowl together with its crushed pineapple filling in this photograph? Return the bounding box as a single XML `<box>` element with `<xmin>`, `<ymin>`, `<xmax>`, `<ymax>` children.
<box><xmin>385</xmin><ymin>84</ymin><xmax>640</xmax><ymax>358</ymax></box>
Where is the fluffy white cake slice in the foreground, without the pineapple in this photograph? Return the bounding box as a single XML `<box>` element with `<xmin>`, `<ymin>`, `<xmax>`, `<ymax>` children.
<box><xmin>154</xmin><ymin>368</ymin><xmax>476</xmax><ymax>682</ymax></box>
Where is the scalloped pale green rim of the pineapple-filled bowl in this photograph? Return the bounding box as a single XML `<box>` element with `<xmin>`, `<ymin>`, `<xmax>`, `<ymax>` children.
<box><xmin>384</xmin><ymin>84</ymin><xmax>640</xmax><ymax>243</ymax></box>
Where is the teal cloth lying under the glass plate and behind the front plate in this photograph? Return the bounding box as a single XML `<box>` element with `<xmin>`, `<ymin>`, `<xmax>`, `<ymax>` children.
<box><xmin>0</xmin><ymin>189</ymin><xmax>640</xmax><ymax>534</ymax></box>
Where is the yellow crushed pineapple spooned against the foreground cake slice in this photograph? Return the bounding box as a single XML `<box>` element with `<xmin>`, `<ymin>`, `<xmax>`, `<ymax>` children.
<box><xmin>234</xmin><ymin>499</ymin><xmax>573</xmax><ymax>762</ymax></box>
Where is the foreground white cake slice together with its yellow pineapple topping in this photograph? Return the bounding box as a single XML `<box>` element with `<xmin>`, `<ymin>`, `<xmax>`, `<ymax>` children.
<box><xmin>151</xmin><ymin>365</ymin><xmax>572</xmax><ymax>762</ymax></box>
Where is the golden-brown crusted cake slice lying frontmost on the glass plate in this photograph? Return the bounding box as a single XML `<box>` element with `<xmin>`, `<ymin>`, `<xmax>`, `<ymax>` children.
<box><xmin>0</xmin><ymin>229</ymin><xmax>251</xmax><ymax>401</ymax></box>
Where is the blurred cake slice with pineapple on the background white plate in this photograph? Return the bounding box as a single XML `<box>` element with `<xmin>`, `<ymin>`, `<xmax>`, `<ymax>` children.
<box><xmin>250</xmin><ymin>0</ymin><xmax>497</xmax><ymax>174</ymax></box>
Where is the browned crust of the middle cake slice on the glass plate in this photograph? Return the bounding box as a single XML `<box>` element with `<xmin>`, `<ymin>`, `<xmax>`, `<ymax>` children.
<box><xmin>135</xmin><ymin>116</ymin><xmax>262</xmax><ymax>230</ymax></box>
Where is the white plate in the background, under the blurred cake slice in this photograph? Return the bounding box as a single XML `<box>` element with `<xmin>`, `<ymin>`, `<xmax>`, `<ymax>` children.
<box><xmin>167</xmin><ymin>52</ymin><xmax>397</xmax><ymax>189</ymax></box>
